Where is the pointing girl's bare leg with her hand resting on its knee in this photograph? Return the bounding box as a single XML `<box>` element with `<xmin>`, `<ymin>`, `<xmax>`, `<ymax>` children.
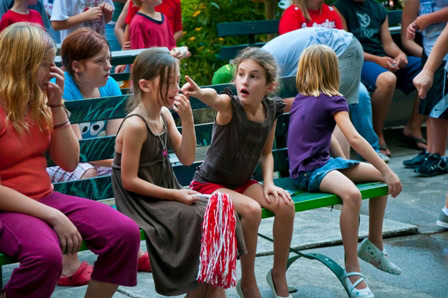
<box><xmin>244</xmin><ymin>184</ymin><xmax>295</xmax><ymax>297</ymax></box>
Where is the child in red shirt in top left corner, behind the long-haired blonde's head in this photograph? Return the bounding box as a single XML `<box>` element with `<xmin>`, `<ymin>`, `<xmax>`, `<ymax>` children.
<box><xmin>0</xmin><ymin>0</ymin><xmax>44</xmax><ymax>31</ymax></box>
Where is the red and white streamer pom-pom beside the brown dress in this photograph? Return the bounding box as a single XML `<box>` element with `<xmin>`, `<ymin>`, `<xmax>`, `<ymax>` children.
<box><xmin>197</xmin><ymin>192</ymin><xmax>237</xmax><ymax>289</ymax></box>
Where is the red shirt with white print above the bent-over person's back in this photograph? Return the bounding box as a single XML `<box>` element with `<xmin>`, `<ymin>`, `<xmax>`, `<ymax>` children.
<box><xmin>278</xmin><ymin>4</ymin><xmax>343</xmax><ymax>34</ymax></box>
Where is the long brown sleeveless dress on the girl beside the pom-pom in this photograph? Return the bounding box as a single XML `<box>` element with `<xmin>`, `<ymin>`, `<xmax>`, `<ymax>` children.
<box><xmin>112</xmin><ymin>114</ymin><xmax>246</xmax><ymax>296</ymax></box>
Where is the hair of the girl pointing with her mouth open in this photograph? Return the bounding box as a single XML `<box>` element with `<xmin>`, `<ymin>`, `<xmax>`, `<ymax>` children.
<box><xmin>233</xmin><ymin>47</ymin><xmax>279</xmax><ymax>93</ymax></box>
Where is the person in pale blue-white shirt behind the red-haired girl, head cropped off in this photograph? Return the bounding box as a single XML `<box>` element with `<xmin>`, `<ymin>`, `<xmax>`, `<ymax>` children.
<box><xmin>51</xmin><ymin>0</ymin><xmax>114</xmax><ymax>42</ymax></box>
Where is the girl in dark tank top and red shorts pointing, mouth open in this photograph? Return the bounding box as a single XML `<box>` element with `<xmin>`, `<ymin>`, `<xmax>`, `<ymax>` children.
<box><xmin>182</xmin><ymin>48</ymin><xmax>295</xmax><ymax>297</ymax></box>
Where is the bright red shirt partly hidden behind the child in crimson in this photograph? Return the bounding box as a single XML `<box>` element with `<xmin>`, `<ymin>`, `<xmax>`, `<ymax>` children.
<box><xmin>125</xmin><ymin>0</ymin><xmax>182</xmax><ymax>34</ymax></box>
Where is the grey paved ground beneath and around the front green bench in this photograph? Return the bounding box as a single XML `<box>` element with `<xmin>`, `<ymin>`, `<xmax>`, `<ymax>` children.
<box><xmin>3</xmin><ymin>131</ymin><xmax>448</xmax><ymax>298</ymax></box>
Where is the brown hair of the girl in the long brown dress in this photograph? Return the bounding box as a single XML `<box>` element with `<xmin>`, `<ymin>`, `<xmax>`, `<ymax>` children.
<box><xmin>128</xmin><ymin>47</ymin><xmax>179</xmax><ymax>111</ymax></box>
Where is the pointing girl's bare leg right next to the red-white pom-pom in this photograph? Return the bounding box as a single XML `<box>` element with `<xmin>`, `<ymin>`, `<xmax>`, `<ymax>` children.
<box><xmin>217</xmin><ymin>188</ymin><xmax>261</xmax><ymax>297</ymax></box>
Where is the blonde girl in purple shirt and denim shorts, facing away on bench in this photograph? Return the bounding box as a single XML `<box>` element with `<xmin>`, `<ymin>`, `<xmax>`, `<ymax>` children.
<box><xmin>288</xmin><ymin>45</ymin><xmax>401</xmax><ymax>297</ymax></box>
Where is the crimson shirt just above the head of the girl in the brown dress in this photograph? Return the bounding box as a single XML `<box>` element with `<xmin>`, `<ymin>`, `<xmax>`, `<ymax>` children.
<box><xmin>129</xmin><ymin>12</ymin><xmax>176</xmax><ymax>50</ymax></box>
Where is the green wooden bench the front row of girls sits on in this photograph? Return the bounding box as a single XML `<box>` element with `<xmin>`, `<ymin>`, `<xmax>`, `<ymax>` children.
<box><xmin>0</xmin><ymin>77</ymin><xmax>387</xmax><ymax>296</ymax></box>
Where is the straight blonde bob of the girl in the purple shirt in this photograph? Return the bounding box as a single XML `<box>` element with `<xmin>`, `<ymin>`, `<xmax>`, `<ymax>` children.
<box><xmin>296</xmin><ymin>45</ymin><xmax>341</xmax><ymax>97</ymax></box>
